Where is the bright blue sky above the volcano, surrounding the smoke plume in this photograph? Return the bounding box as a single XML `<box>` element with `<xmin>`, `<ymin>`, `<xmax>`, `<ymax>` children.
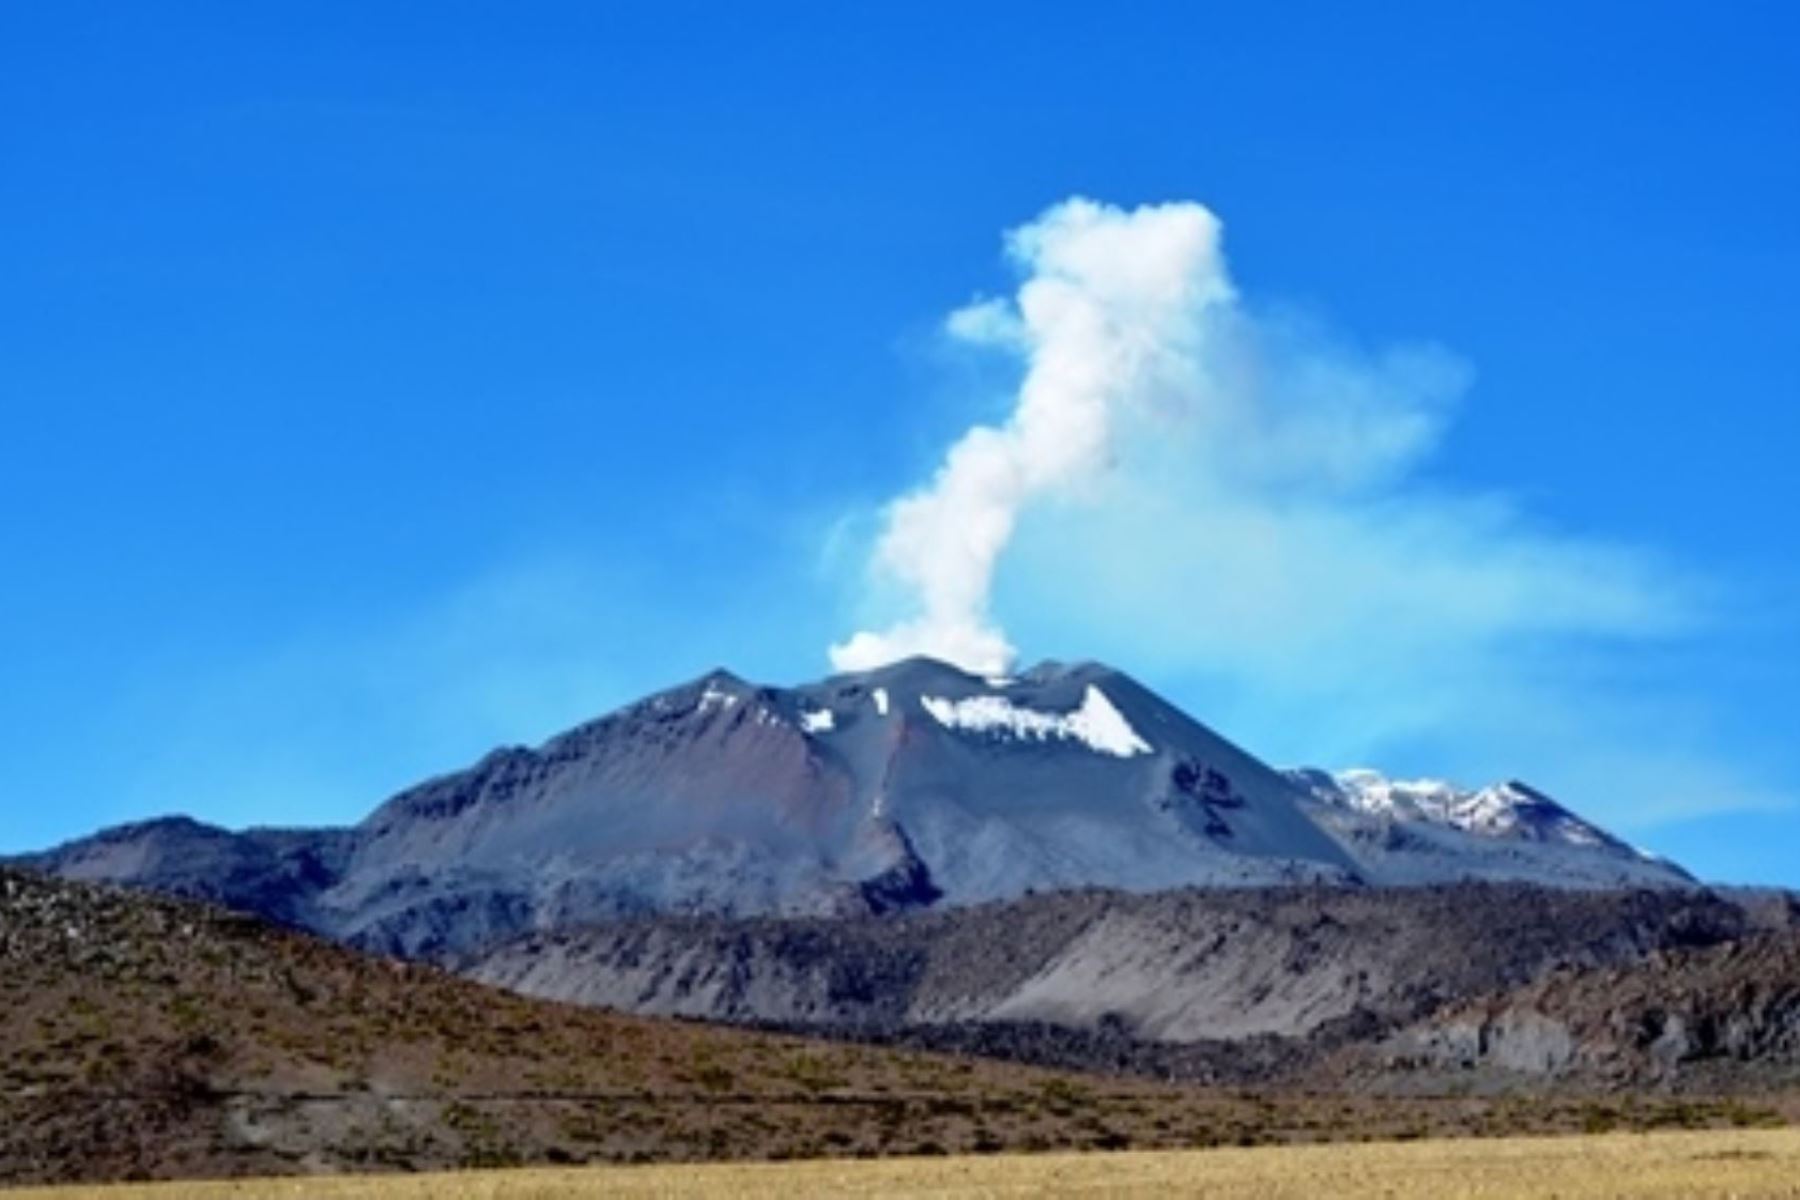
<box><xmin>0</xmin><ymin>2</ymin><xmax>1800</xmax><ymax>883</ymax></box>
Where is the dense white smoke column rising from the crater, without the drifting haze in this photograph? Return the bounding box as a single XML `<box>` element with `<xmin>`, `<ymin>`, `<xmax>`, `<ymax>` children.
<box><xmin>830</xmin><ymin>198</ymin><xmax>1233</xmax><ymax>675</ymax></box>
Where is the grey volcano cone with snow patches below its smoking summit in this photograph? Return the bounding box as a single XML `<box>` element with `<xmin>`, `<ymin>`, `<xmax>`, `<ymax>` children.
<box><xmin>22</xmin><ymin>658</ymin><xmax>1688</xmax><ymax>955</ymax></box>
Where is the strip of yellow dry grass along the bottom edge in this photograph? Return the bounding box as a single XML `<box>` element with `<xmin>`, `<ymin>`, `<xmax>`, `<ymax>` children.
<box><xmin>5</xmin><ymin>1128</ymin><xmax>1800</xmax><ymax>1200</ymax></box>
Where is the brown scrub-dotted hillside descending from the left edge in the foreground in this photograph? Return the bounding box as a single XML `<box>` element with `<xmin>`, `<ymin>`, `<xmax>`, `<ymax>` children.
<box><xmin>0</xmin><ymin>871</ymin><xmax>1778</xmax><ymax>1184</ymax></box>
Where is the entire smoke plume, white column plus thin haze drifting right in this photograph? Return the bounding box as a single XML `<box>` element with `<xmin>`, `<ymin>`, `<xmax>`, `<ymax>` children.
<box><xmin>830</xmin><ymin>200</ymin><xmax>1777</xmax><ymax>826</ymax></box>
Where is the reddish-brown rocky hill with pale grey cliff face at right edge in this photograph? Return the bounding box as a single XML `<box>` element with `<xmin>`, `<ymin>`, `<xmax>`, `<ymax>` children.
<box><xmin>1379</xmin><ymin>932</ymin><xmax>1800</xmax><ymax>1087</ymax></box>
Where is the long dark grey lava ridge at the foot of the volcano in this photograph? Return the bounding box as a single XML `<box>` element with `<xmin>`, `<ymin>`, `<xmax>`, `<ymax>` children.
<box><xmin>461</xmin><ymin>883</ymin><xmax>1746</xmax><ymax>1061</ymax></box>
